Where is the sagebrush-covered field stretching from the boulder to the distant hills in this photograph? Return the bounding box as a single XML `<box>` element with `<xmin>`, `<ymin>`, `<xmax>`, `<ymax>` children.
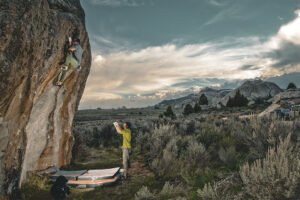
<box><xmin>21</xmin><ymin>105</ymin><xmax>300</xmax><ymax>200</ymax></box>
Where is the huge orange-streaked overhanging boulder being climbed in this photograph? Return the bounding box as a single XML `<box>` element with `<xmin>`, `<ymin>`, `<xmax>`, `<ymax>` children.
<box><xmin>0</xmin><ymin>0</ymin><xmax>91</xmax><ymax>198</ymax></box>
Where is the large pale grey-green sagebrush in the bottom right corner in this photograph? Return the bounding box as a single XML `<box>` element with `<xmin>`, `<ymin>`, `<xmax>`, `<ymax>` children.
<box><xmin>240</xmin><ymin>134</ymin><xmax>300</xmax><ymax>200</ymax></box>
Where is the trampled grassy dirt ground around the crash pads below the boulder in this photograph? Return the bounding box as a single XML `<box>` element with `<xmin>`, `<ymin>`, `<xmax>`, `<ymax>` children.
<box><xmin>21</xmin><ymin>148</ymin><xmax>158</xmax><ymax>200</ymax></box>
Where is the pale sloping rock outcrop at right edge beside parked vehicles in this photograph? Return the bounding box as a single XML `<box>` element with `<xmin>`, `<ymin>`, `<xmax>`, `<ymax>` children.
<box><xmin>259</xmin><ymin>89</ymin><xmax>300</xmax><ymax>117</ymax></box>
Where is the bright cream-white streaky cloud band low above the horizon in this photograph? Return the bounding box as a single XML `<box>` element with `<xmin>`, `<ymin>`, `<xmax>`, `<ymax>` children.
<box><xmin>81</xmin><ymin>11</ymin><xmax>300</xmax><ymax>107</ymax></box>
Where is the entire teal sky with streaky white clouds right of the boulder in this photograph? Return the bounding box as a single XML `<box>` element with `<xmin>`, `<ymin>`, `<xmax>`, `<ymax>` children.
<box><xmin>80</xmin><ymin>0</ymin><xmax>300</xmax><ymax>109</ymax></box>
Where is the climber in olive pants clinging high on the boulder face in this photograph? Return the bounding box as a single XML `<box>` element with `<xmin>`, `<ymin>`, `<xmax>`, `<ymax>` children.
<box><xmin>56</xmin><ymin>38</ymin><xmax>82</xmax><ymax>86</ymax></box>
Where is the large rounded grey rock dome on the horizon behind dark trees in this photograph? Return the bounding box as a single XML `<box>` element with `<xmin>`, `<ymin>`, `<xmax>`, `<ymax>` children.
<box><xmin>218</xmin><ymin>80</ymin><xmax>282</xmax><ymax>106</ymax></box>
